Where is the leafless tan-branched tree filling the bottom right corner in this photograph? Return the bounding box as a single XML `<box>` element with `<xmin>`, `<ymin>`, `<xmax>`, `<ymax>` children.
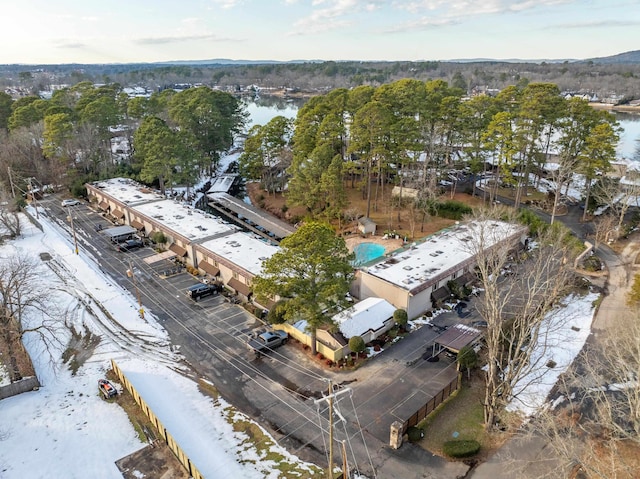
<box><xmin>530</xmin><ymin>309</ymin><xmax>640</xmax><ymax>479</ymax></box>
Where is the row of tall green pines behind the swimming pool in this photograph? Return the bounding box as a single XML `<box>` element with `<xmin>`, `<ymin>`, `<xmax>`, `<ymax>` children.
<box><xmin>239</xmin><ymin>79</ymin><xmax>620</xmax><ymax>230</ymax></box>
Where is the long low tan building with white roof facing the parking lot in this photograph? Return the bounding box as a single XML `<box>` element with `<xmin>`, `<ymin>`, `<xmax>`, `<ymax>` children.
<box><xmin>86</xmin><ymin>178</ymin><xmax>278</xmax><ymax>299</ymax></box>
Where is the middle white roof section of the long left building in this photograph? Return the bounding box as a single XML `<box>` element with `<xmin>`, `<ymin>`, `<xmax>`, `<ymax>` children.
<box><xmin>131</xmin><ymin>200</ymin><xmax>238</xmax><ymax>241</ymax></box>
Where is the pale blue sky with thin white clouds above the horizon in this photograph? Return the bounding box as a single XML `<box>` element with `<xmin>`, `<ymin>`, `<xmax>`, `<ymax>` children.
<box><xmin>0</xmin><ymin>0</ymin><xmax>640</xmax><ymax>64</ymax></box>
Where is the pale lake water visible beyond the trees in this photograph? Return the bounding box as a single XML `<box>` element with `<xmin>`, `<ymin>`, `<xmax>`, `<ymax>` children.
<box><xmin>245</xmin><ymin>97</ymin><xmax>640</xmax><ymax>159</ymax></box>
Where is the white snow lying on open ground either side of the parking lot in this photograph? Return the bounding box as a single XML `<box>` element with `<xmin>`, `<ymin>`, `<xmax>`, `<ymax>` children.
<box><xmin>0</xmin><ymin>189</ymin><xmax>595</xmax><ymax>479</ymax></box>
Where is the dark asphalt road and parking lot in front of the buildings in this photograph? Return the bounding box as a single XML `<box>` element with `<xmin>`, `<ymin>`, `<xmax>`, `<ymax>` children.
<box><xmin>40</xmin><ymin>198</ymin><xmax>468</xmax><ymax>479</ymax></box>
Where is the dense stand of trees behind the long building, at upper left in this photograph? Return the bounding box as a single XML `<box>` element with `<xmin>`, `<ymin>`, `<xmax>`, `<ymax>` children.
<box><xmin>0</xmin><ymin>82</ymin><xmax>246</xmax><ymax>194</ymax></box>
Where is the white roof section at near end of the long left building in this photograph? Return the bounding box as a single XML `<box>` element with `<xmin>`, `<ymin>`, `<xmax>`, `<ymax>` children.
<box><xmin>201</xmin><ymin>232</ymin><xmax>279</xmax><ymax>275</ymax></box>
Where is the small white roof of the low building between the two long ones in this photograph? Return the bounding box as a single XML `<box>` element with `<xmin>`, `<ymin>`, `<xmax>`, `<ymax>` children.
<box><xmin>333</xmin><ymin>298</ymin><xmax>396</xmax><ymax>339</ymax></box>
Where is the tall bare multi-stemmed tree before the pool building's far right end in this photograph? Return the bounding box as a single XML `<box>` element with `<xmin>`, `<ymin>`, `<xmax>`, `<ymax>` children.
<box><xmin>467</xmin><ymin>210</ymin><xmax>571</xmax><ymax>430</ymax></box>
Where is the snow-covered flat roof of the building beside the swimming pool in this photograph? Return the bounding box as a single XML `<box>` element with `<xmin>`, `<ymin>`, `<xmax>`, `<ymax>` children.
<box><xmin>362</xmin><ymin>221</ymin><xmax>524</xmax><ymax>291</ymax></box>
